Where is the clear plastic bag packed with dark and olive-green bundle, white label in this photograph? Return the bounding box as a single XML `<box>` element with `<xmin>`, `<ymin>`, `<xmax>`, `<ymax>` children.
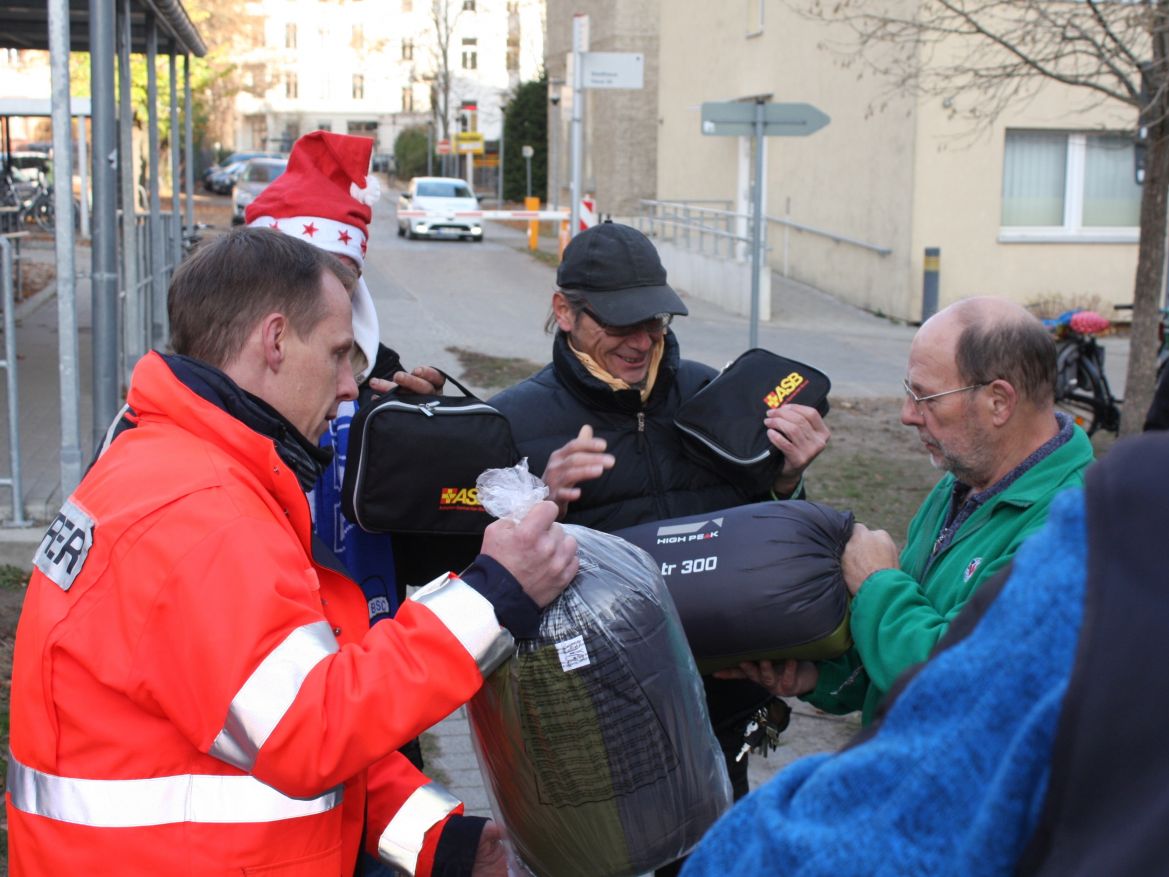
<box><xmin>469</xmin><ymin>526</ymin><xmax>731</xmax><ymax>877</ymax></box>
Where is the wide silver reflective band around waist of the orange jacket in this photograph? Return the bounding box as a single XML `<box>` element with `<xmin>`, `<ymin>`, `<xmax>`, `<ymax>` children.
<box><xmin>8</xmin><ymin>752</ymin><xmax>344</xmax><ymax>828</ymax></box>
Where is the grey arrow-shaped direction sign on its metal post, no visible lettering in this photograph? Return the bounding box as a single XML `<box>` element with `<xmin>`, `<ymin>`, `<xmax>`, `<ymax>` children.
<box><xmin>703</xmin><ymin>99</ymin><xmax>831</xmax><ymax>347</ymax></box>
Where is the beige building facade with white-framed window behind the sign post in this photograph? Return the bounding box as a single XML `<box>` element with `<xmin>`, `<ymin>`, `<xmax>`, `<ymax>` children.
<box><xmin>659</xmin><ymin>0</ymin><xmax>1140</xmax><ymax>322</ymax></box>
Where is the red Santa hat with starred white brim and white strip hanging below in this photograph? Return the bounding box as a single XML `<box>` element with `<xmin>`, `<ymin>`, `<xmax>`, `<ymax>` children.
<box><xmin>244</xmin><ymin>131</ymin><xmax>381</xmax><ymax>384</ymax></box>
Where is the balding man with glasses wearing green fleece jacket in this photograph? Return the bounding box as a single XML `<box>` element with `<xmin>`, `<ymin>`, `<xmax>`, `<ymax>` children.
<box><xmin>732</xmin><ymin>298</ymin><xmax>1093</xmax><ymax>725</ymax></box>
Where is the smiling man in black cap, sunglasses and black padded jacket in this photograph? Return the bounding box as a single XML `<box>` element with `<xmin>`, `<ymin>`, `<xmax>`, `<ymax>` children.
<box><xmin>491</xmin><ymin>222</ymin><xmax>829</xmax><ymax>873</ymax></box>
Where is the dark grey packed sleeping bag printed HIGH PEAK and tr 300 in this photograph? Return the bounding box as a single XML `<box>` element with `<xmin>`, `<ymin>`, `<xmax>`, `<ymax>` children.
<box><xmin>616</xmin><ymin>499</ymin><xmax>853</xmax><ymax>674</ymax></box>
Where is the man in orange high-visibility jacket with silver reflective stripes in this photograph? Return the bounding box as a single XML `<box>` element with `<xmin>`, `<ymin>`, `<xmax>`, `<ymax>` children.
<box><xmin>7</xmin><ymin>229</ymin><xmax>576</xmax><ymax>877</ymax></box>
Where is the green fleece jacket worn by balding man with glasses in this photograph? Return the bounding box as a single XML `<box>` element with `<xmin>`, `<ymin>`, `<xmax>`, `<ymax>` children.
<box><xmin>804</xmin><ymin>427</ymin><xmax>1093</xmax><ymax>725</ymax></box>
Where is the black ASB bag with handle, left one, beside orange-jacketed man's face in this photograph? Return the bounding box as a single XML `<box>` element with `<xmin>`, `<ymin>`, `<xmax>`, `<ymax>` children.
<box><xmin>341</xmin><ymin>374</ymin><xmax>519</xmax><ymax>587</ymax></box>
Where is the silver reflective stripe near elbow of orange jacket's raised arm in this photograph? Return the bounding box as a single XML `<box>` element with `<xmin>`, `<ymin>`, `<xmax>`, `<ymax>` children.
<box><xmin>210</xmin><ymin>621</ymin><xmax>340</xmax><ymax>772</ymax></box>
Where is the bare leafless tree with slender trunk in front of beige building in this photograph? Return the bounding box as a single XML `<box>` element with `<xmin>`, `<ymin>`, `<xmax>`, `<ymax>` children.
<box><xmin>788</xmin><ymin>0</ymin><xmax>1169</xmax><ymax>434</ymax></box>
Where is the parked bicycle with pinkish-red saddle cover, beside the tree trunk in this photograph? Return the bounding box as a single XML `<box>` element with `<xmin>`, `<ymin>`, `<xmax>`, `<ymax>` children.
<box><xmin>1043</xmin><ymin>310</ymin><xmax>1123</xmax><ymax>435</ymax></box>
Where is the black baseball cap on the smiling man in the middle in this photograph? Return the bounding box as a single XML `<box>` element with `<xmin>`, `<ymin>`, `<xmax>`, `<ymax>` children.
<box><xmin>556</xmin><ymin>222</ymin><xmax>690</xmax><ymax>326</ymax></box>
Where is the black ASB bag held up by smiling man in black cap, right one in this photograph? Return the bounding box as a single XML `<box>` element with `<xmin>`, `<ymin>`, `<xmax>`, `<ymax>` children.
<box><xmin>673</xmin><ymin>347</ymin><xmax>832</xmax><ymax>488</ymax></box>
